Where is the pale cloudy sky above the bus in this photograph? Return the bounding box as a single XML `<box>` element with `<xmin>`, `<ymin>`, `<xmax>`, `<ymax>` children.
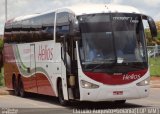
<box><xmin>0</xmin><ymin>0</ymin><xmax>160</xmax><ymax>34</ymax></box>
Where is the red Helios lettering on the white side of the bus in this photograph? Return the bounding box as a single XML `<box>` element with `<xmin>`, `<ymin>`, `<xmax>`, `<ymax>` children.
<box><xmin>38</xmin><ymin>45</ymin><xmax>53</xmax><ymax>61</ymax></box>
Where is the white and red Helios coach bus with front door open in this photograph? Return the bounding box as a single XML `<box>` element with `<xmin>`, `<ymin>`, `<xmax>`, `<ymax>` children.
<box><xmin>3</xmin><ymin>4</ymin><xmax>157</xmax><ymax>105</ymax></box>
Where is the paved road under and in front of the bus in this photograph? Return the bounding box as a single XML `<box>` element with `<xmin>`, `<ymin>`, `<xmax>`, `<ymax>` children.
<box><xmin>0</xmin><ymin>88</ymin><xmax>160</xmax><ymax>114</ymax></box>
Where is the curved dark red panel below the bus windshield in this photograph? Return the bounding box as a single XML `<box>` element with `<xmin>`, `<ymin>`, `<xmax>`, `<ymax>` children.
<box><xmin>84</xmin><ymin>69</ymin><xmax>147</xmax><ymax>85</ymax></box>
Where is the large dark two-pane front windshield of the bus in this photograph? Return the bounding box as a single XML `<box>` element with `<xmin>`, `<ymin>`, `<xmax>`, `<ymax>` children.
<box><xmin>78</xmin><ymin>13</ymin><xmax>147</xmax><ymax>72</ymax></box>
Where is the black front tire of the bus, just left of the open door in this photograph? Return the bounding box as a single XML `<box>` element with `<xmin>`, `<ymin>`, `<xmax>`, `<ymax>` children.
<box><xmin>58</xmin><ymin>81</ymin><xmax>67</xmax><ymax>106</ymax></box>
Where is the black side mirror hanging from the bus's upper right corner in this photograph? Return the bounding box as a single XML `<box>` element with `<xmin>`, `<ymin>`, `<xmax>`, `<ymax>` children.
<box><xmin>147</xmin><ymin>17</ymin><xmax>157</xmax><ymax>37</ymax></box>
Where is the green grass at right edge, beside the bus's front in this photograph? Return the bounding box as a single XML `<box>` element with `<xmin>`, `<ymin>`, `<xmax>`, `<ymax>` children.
<box><xmin>149</xmin><ymin>57</ymin><xmax>160</xmax><ymax>77</ymax></box>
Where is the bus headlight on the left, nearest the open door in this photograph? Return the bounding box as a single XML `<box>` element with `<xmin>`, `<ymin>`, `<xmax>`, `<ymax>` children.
<box><xmin>81</xmin><ymin>80</ymin><xmax>99</xmax><ymax>89</ymax></box>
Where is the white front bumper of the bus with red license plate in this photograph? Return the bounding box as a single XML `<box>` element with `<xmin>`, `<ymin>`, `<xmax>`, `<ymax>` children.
<box><xmin>80</xmin><ymin>84</ymin><xmax>150</xmax><ymax>102</ymax></box>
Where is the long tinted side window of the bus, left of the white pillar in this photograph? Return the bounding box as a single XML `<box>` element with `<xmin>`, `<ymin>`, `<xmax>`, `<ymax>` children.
<box><xmin>5</xmin><ymin>12</ymin><xmax>55</xmax><ymax>43</ymax></box>
